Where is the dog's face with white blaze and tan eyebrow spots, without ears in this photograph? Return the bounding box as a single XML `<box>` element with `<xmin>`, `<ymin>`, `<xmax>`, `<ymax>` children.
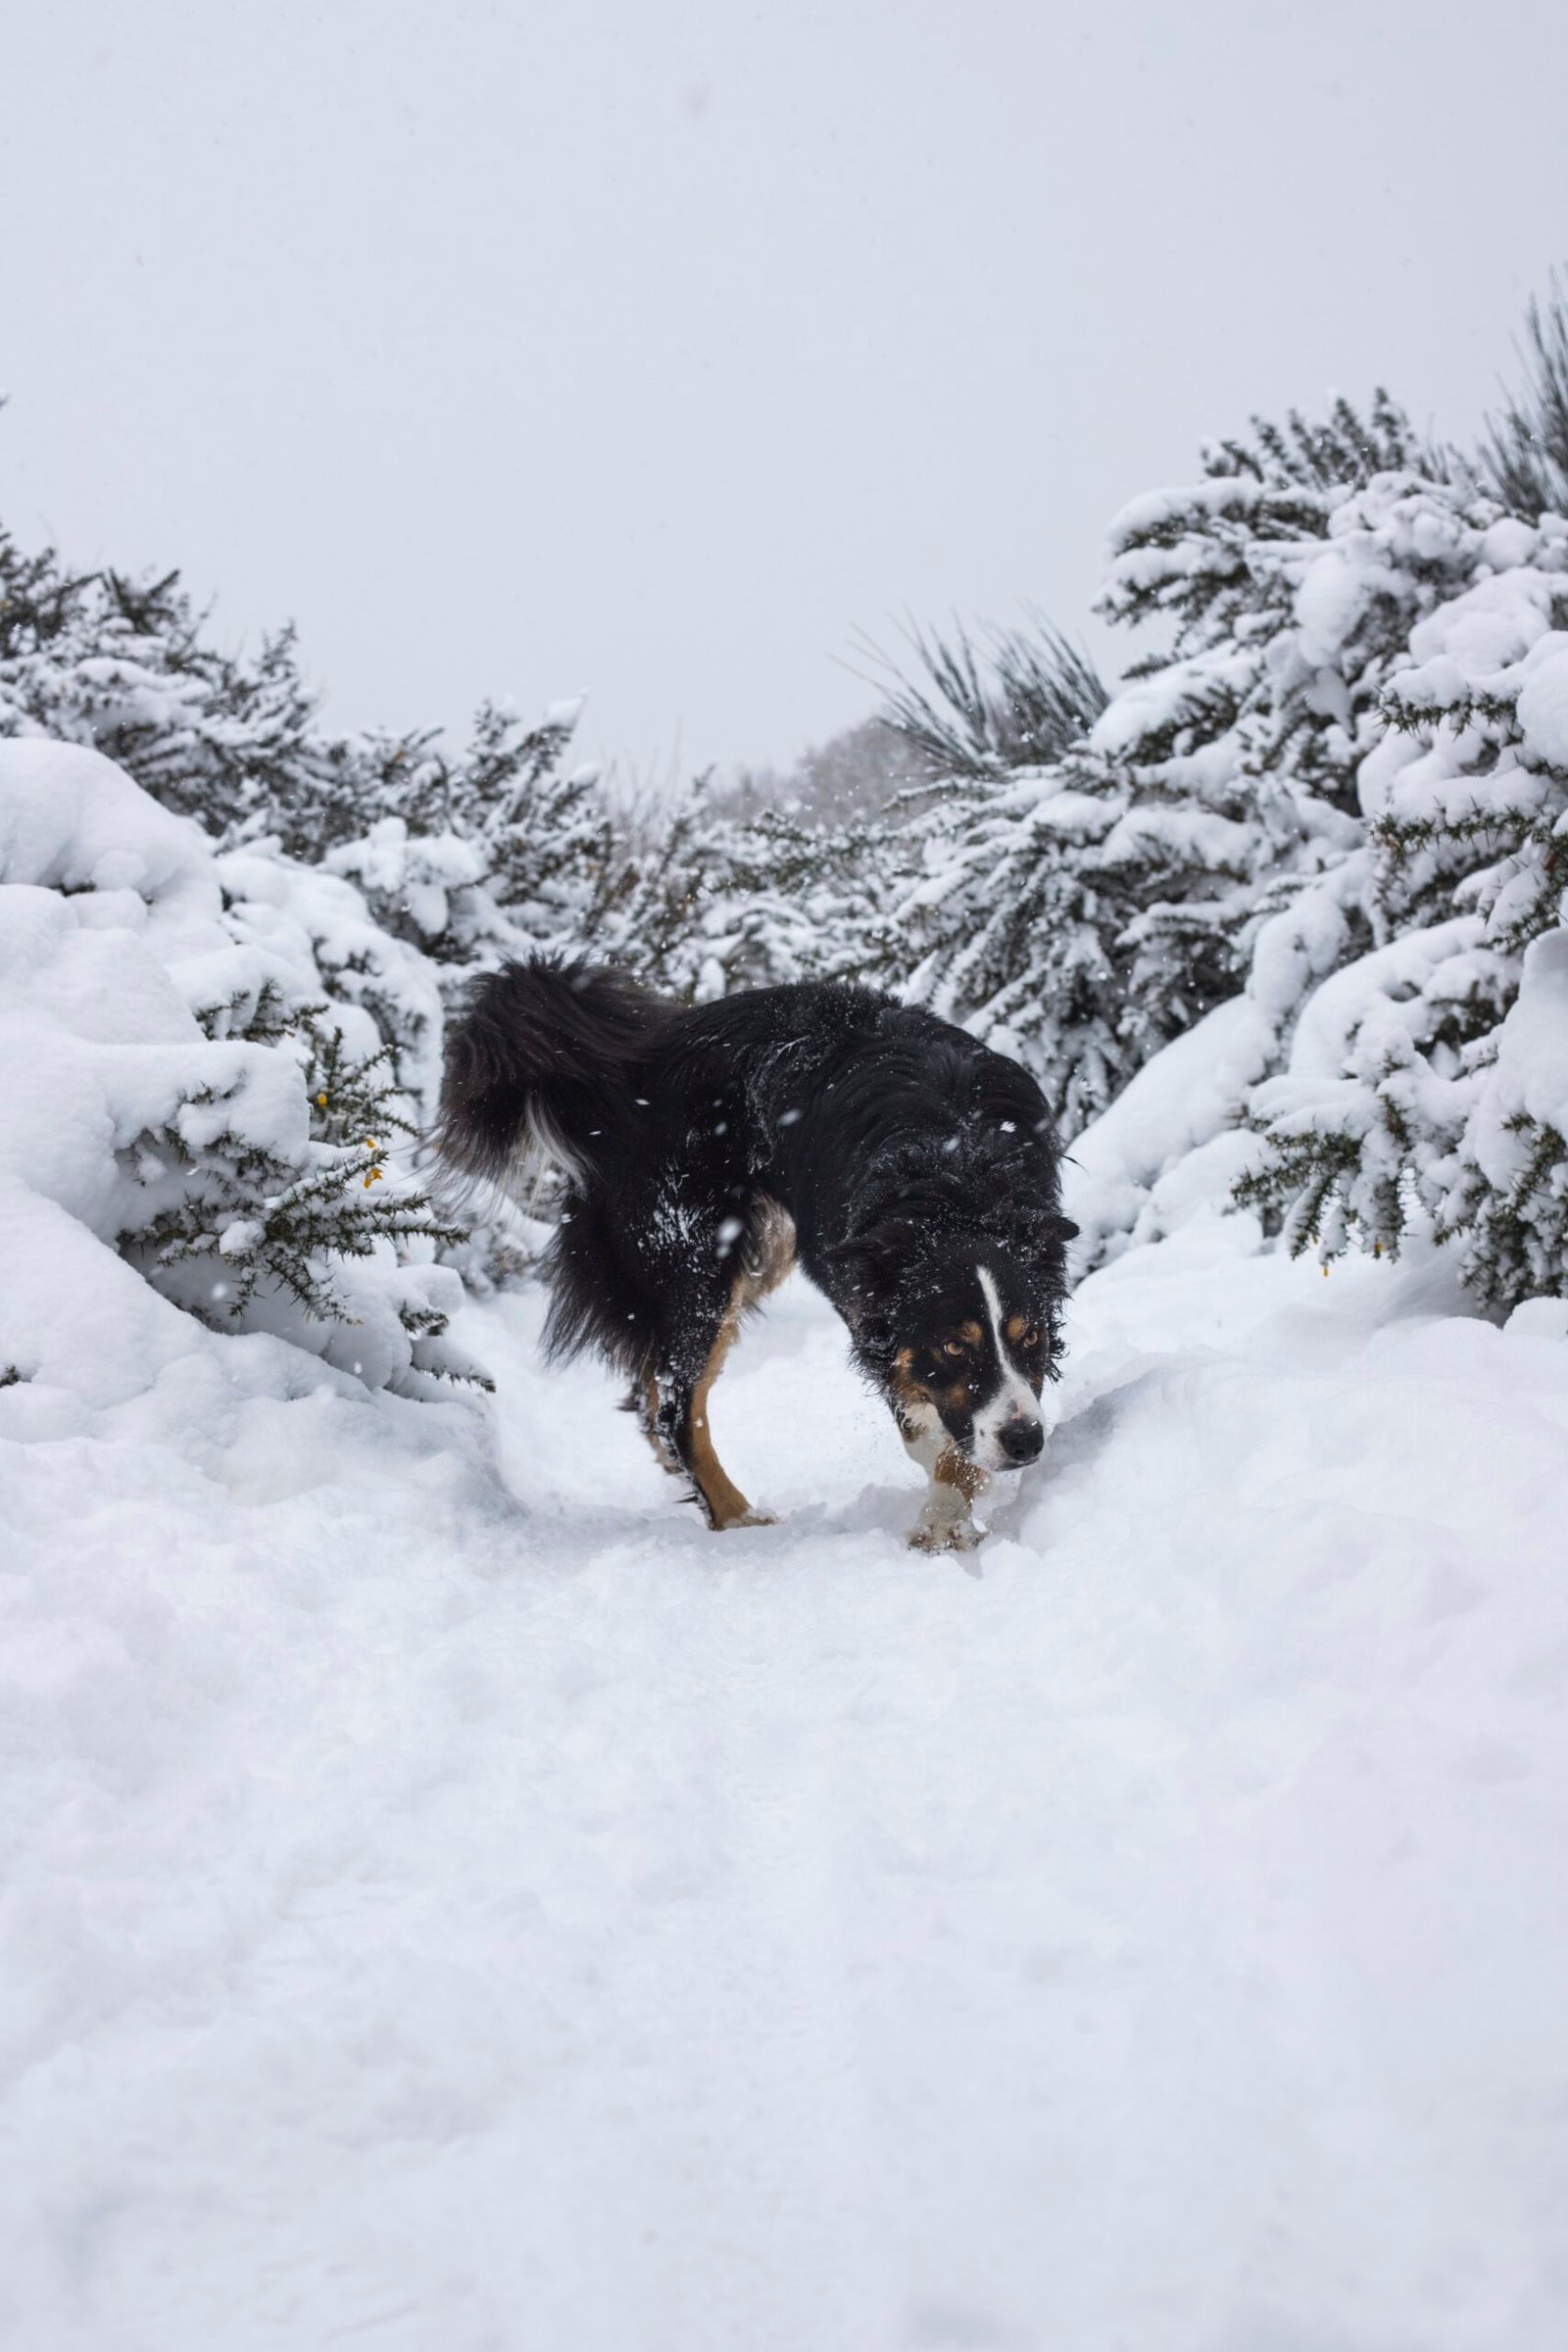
<box><xmin>896</xmin><ymin>1258</ymin><xmax>1046</xmax><ymax>1470</ymax></box>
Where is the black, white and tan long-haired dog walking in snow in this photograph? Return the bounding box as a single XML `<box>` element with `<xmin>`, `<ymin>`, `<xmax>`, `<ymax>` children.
<box><xmin>435</xmin><ymin>957</ymin><xmax>1077</xmax><ymax>1552</ymax></box>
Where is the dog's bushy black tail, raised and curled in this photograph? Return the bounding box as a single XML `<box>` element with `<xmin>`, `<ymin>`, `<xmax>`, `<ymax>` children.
<box><xmin>432</xmin><ymin>955</ymin><xmax>674</xmax><ymax>1183</ymax></box>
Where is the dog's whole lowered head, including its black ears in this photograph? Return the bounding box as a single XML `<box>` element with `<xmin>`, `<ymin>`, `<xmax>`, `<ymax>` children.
<box><xmin>856</xmin><ymin>1218</ymin><xmax>1074</xmax><ymax>1470</ymax></box>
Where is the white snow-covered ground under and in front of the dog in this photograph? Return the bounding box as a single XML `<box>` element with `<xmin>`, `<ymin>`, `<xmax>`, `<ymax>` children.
<box><xmin>0</xmin><ymin>1225</ymin><xmax>1568</xmax><ymax>2352</ymax></box>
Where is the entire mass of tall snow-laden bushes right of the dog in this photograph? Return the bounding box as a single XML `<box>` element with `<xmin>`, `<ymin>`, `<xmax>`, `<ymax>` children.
<box><xmin>869</xmin><ymin>338</ymin><xmax>1568</xmax><ymax>1303</ymax></box>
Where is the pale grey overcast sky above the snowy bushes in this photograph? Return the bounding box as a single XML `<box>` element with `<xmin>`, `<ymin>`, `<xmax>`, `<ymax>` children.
<box><xmin>0</xmin><ymin>0</ymin><xmax>1568</xmax><ymax>769</ymax></box>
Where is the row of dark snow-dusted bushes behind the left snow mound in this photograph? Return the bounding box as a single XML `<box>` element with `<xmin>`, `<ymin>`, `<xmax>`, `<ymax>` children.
<box><xmin>0</xmin><ymin>531</ymin><xmax>635</xmax><ymax>1049</ymax></box>
